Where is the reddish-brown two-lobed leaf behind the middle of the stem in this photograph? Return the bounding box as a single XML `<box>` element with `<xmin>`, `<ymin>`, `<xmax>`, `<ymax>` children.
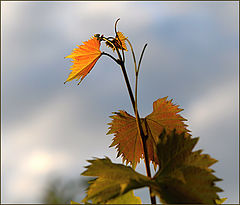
<box><xmin>107</xmin><ymin>97</ymin><xmax>189</xmax><ymax>167</ymax></box>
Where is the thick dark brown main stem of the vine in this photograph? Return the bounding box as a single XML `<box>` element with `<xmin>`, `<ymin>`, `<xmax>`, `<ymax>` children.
<box><xmin>120</xmin><ymin>61</ymin><xmax>156</xmax><ymax>204</ymax></box>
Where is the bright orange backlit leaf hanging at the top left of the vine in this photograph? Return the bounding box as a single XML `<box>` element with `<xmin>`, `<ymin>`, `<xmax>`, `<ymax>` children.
<box><xmin>65</xmin><ymin>37</ymin><xmax>101</xmax><ymax>84</ymax></box>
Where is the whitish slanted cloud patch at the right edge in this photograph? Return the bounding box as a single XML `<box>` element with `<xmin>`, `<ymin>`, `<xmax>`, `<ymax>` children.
<box><xmin>187</xmin><ymin>77</ymin><xmax>239</xmax><ymax>133</ymax></box>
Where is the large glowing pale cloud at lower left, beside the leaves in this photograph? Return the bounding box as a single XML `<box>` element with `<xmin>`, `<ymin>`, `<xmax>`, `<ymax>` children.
<box><xmin>2</xmin><ymin>92</ymin><xmax>122</xmax><ymax>203</ymax></box>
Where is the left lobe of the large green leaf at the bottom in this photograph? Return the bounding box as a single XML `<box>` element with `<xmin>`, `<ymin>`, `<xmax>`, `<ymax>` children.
<box><xmin>82</xmin><ymin>158</ymin><xmax>151</xmax><ymax>203</ymax></box>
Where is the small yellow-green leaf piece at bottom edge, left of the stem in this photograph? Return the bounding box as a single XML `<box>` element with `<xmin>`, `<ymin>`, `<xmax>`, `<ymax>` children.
<box><xmin>106</xmin><ymin>191</ymin><xmax>142</xmax><ymax>204</ymax></box>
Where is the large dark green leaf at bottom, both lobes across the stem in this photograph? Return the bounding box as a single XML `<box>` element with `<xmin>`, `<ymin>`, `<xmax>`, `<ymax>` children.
<box><xmin>82</xmin><ymin>129</ymin><xmax>222</xmax><ymax>204</ymax></box>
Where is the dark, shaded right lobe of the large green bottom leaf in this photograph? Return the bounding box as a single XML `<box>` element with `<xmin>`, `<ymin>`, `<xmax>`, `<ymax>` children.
<box><xmin>153</xmin><ymin>130</ymin><xmax>222</xmax><ymax>204</ymax></box>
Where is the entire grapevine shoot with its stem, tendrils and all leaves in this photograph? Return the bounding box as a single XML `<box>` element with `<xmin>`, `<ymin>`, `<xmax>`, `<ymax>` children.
<box><xmin>65</xmin><ymin>19</ymin><xmax>225</xmax><ymax>204</ymax></box>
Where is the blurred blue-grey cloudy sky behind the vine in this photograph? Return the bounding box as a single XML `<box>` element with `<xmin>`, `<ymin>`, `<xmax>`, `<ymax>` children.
<box><xmin>1</xmin><ymin>1</ymin><xmax>239</xmax><ymax>203</ymax></box>
